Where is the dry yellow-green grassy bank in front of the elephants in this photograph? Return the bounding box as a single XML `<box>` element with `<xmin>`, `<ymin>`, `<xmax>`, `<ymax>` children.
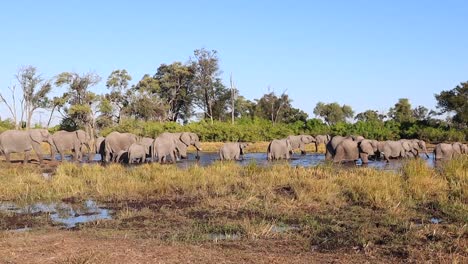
<box><xmin>0</xmin><ymin>156</ymin><xmax>468</xmax><ymax>262</ymax></box>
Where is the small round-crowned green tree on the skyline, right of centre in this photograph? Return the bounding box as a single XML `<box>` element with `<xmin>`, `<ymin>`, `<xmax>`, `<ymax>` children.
<box><xmin>314</xmin><ymin>102</ymin><xmax>354</xmax><ymax>126</ymax></box>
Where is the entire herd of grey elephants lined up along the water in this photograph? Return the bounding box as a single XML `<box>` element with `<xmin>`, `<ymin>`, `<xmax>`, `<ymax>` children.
<box><xmin>0</xmin><ymin>129</ymin><xmax>468</xmax><ymax>163</ymax></box>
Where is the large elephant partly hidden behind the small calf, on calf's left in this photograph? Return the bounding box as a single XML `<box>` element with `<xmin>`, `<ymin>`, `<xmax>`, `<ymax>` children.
<box><xmin>104</xmin><ymin>132</ymin><xmax>137</xmax><ymax>162</ymax></box>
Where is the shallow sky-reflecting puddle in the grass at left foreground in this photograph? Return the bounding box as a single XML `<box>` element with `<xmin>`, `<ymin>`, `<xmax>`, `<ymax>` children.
<box><xmin>0</xmin><ymin>200</ymin><xmax>112</xmax><ymax>232</ymax></box>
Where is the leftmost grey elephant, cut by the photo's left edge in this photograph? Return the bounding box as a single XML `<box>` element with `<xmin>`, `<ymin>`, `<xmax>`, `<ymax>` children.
<box><xmin>0</xmin><ymin>129</ymin><xmax>53</xmax><ymax>164</ymax></box>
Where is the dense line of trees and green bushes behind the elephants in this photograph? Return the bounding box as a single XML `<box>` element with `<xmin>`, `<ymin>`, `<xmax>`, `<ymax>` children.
<box><xmin>0</xmin><ymin>49</ymin><xmax>468</xmax><ymax>142</ymax></box>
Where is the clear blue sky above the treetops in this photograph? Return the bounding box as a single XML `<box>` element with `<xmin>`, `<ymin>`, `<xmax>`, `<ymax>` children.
<box><xmin>0</xmin><ymin>0</ymin><xmax>468</xmax><ymax>124</ymax></box>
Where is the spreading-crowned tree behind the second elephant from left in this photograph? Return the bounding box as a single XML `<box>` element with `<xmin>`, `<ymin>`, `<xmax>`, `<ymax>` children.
<box><xmin>55</xmin><ymin>72</ymin><xmax>101</xmax><ymax>139</ymax></box>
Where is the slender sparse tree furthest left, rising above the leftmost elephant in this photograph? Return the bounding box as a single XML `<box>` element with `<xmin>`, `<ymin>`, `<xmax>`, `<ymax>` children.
<box><xmin>16</xmin><ymin>66</ymin><xmax>52</xmax><ymax>129</ymax></box>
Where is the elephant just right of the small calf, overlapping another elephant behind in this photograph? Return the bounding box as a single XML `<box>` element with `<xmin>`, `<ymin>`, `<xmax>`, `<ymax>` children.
<box><xmin>154</xmin><ymin>132</ymin><xmax>181</xmax><ymax>163</ymax></box>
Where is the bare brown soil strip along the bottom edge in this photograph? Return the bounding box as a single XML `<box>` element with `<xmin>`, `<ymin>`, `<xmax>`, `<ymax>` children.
<box><xmin>0</xmin><ymin>230</ymin><xmax>392</xmax><ymax>264</ymax></box>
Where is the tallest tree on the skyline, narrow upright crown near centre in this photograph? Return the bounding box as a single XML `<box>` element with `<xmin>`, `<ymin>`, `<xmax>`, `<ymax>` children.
<box><xmin>191</xmin><ymin>48</ymin><xmax>221</xmax><ymax>123</ymax></box>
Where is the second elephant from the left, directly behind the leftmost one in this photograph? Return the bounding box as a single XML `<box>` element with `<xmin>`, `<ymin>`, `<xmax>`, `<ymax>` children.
<box><xmin>50</xmin><ymin>130</ymin><xmax>91</xmax><ymax>161</ymax></box>
